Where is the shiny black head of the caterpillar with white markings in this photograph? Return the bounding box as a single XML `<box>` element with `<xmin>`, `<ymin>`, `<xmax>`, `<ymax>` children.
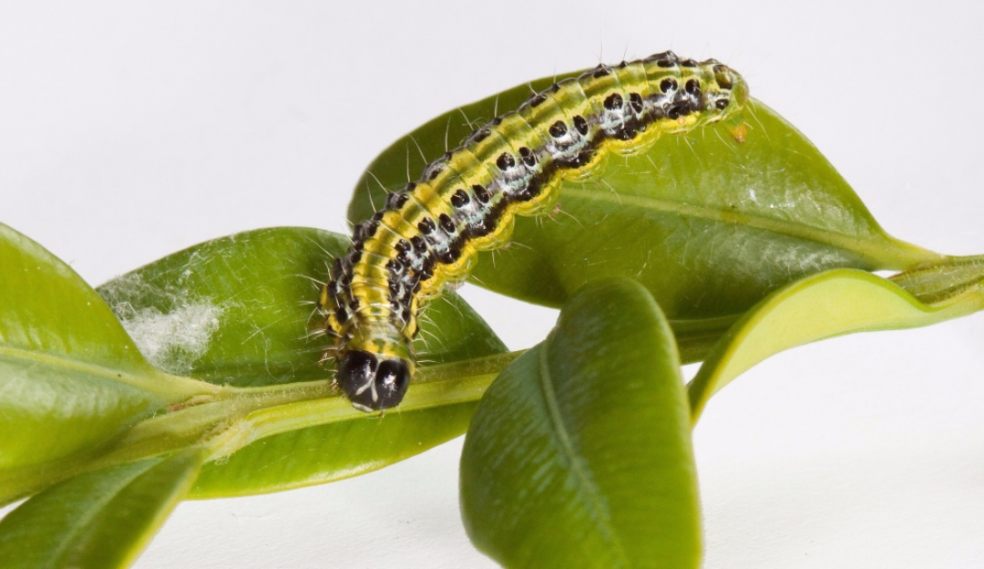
<box><xmin>337</xmin><ymin>350</ymin><xmax>410</xmax><ymax>411</ymax></box>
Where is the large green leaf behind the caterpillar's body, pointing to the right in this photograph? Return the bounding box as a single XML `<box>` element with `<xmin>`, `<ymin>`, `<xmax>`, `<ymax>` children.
<box><xmin>348</xmin><ymin>77</ymin><xmax>940</xmax><ymax>352</ymax></box>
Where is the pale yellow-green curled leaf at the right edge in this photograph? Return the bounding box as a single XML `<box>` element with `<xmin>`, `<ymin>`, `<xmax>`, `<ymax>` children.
<box><xmin>688</xmin><ymin>266</ymin><xmax>984</xmax><ymax>423</ymax></box>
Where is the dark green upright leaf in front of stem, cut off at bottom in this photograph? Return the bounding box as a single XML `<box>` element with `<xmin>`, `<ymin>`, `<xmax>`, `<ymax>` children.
<box><xmin>461</xmin><ymin>279</ymin><xmax>701</xmax><ymax>569</ymax></box>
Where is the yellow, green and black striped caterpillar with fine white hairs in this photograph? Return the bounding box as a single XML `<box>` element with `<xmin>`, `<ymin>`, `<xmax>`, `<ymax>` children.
<box><xmin>318</xmin><ymin>51</ymin><xmax>748</xmax><ymax>411</ymax></box>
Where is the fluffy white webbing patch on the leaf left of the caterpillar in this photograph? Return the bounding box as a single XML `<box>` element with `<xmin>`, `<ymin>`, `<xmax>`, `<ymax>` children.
<box><xmin>117</xmin><ymin>300</ymin><xmax>222</xmax><ymax>373</ymax></box>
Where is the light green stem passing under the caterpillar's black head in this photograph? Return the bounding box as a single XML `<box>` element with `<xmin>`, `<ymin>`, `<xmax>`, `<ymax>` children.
<box><xmin>0</xmin><ymin>351</ymin><xmax>522</xmax><ymax>503</ymax></box>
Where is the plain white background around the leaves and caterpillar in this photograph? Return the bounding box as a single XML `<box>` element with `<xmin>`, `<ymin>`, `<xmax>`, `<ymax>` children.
<box><xmin>0</xmin><ymin>0</ymin><xmax>984</xmax><ymax>569</ymax></box>
